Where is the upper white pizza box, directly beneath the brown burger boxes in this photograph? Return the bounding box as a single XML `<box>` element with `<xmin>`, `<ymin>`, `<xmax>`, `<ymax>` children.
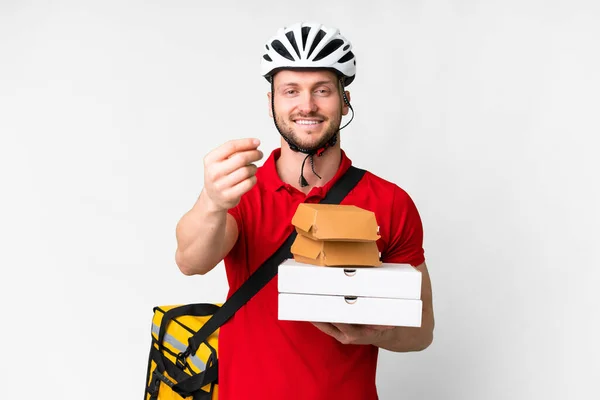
<box><xmin>278</xmin><ymin>259</ymin><xmax>421</xmax><ymax>300</ymax></box>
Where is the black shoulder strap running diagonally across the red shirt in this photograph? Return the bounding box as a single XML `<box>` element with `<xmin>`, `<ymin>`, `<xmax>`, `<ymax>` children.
<box><xmin>185</xmin><ymin>167</ymin><xmax>366</xmax><ymax>355</ymax></box>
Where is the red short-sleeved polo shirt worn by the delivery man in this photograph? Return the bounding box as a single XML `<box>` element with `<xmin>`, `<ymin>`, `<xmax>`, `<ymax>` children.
<box><xmin>219</xmin><ymin>149</ymin><xmax>425</xmax><ymax>400</ymax></box>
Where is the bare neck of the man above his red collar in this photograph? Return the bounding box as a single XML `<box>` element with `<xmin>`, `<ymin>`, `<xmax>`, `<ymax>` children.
<box><xmin>275</xmin><ymin>139</ymin><xmax>342</xmax><ymax>194</ymax></box>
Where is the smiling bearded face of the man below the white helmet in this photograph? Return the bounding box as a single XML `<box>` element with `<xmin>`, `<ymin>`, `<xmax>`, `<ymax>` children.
<box><xmin>268</xmin><ymin>70</ymin><xmax>349</xmax><ymax>150</ymax></box>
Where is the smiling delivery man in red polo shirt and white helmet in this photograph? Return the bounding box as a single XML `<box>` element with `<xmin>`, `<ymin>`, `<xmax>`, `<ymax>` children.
<box><xmin>176</xmin><ymin>24</ymin><xmax>434</xmax><ymax>400</ymax></box>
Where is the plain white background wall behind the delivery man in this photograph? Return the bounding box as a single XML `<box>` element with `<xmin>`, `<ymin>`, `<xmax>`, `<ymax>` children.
<box><xmin>0</xmin><ymin>0</ymin><xmax>600</xmax><ymax>400</ymax></box>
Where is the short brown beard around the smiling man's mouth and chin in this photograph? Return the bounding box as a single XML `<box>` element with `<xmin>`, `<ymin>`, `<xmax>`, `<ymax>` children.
<box><xmin>276</xmin><ymin>110</ymin><xmax>342</xmax><ymax>152</ymax></box>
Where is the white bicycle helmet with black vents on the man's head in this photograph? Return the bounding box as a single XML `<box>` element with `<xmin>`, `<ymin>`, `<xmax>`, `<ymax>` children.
<box><xmin>261</xmin><ymin>23</ymin><xmax>356</xmax><ymax>86</ymax></box>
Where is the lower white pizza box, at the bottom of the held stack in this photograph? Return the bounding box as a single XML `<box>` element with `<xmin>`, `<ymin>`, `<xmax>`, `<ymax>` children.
<box><xmin>278</xmin><ymin>293</ymin><xmax>422</xmax><ymax>327</ymax></box>
